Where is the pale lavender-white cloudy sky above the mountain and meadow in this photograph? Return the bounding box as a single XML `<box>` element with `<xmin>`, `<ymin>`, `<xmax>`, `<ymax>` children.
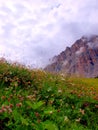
<box><xmin>0</xmin><ymin>0</ymin><xmax>98</xmax><ymax>67</ymax></box>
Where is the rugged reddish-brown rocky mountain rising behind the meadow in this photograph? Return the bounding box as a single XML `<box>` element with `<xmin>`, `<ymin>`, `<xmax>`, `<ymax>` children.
<box><xmin>45</xmin><ymin>35</ymin><xmax>98</xmax><ymax>77</ymax></box>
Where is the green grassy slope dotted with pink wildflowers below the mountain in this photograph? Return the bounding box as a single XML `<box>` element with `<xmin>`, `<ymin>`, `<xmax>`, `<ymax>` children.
<box><xmin>0</xmin><ymin>61</ymin><xmax>98</xmax><ymax>130</ymax></box>
